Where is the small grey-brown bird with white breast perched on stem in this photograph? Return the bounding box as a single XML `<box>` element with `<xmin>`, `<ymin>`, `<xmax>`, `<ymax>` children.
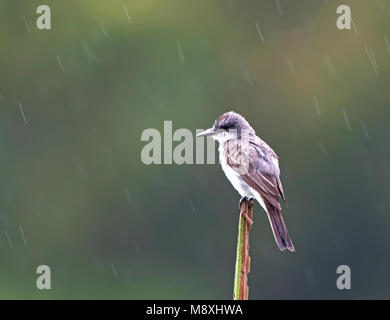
<box><xmin>196</xmin><ymin>111</ymin><xmax>295</xmax><ymax>252</ymax></box>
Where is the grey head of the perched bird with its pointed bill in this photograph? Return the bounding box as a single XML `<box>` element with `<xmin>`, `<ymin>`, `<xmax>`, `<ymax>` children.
<box><xmin>196</xmin><ymin>111</ymin><xmax>255</xmax><ymax>143</ymax></box>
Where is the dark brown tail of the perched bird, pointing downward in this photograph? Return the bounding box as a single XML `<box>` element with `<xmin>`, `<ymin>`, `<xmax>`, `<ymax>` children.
<box><xmin>266</xmin><ymin>203</ymin><xmax>295</xmax><ymax>252</ymax></box>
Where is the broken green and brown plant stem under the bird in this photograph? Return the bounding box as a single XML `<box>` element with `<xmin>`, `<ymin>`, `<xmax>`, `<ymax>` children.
<box><xmin>233</xmin><ymin>200</ymin><xmax>253</xmax><ymax>300</ymax></box>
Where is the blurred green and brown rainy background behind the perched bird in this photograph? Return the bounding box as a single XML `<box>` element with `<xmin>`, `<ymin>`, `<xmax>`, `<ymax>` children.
<box><xmin>0</xmin><ymin>0</ymin><xmax>390</xmax><ymax>299</ymax></box>
